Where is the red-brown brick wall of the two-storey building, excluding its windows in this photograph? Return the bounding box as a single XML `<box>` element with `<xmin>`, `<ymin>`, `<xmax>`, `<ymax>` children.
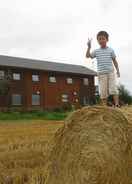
<box><xmin>0</xmin><ymin>69</ymin><xmax>95</xmax><ymax>110</ymax></box>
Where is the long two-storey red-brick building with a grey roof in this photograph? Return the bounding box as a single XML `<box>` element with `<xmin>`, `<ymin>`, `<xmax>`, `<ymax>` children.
<box><xmin>0</xmin><ymin>55</ymin><xmax>96</xmax><ymax>111</ymax></box>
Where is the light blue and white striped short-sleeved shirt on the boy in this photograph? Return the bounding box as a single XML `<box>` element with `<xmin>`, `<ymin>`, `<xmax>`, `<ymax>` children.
<box><xmin>90</xmin><ymin>47</ymin><xmax>116</xmax><ymax>73</ymax></box>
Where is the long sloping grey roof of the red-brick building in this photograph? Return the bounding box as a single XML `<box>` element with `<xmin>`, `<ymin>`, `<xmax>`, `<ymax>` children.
<box><xmin>0</xmin><ymin>55</ymin><xmax>97</xmax><ymax>75</ymax></box>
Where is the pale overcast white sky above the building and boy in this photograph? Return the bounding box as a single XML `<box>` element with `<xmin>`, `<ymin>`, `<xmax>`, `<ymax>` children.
<box><xmin>0</xmin><ymin>0</ymin><xmax>132</xmax><ymax>93</ymax></box>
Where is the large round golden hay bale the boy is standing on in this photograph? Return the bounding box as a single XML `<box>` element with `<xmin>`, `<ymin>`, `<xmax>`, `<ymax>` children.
<box><xmin>46</xmin><ymin>106</ymin><xmax>130</xmax><ymax>184</ymax></box>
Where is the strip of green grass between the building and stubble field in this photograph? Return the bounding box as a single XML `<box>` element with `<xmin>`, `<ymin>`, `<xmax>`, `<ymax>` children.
<box><xmin>0</xmin><ymin>111</ymin><xmax>70</xmax><ymax>120</ymax></box>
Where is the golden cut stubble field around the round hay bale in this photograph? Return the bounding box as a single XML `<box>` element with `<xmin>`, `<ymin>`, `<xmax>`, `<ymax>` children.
<box><xmin>0</xmin><ymin>106</ymin><xmax>132</xmax><ymax>184</ymax></box>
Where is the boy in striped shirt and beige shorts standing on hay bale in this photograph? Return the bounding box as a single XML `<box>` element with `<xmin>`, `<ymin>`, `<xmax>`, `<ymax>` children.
<box><xmin>86</xmin><ymin>31</ymin><xmax>120</xmax><ymax>107</ymax></box>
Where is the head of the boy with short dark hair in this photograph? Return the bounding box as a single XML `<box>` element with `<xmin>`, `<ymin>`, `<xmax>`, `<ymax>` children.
<box><xmin>97</xmin><ymin>31</ymin><xmax>109</xmax><ymax>48</ymax></box>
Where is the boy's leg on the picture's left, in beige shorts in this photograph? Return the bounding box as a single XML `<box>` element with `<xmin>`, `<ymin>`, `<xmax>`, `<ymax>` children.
<box><xmin>98</xmin><ymin>74</ymin><xmax>108</xmax><ymax>105</ymax></box>
